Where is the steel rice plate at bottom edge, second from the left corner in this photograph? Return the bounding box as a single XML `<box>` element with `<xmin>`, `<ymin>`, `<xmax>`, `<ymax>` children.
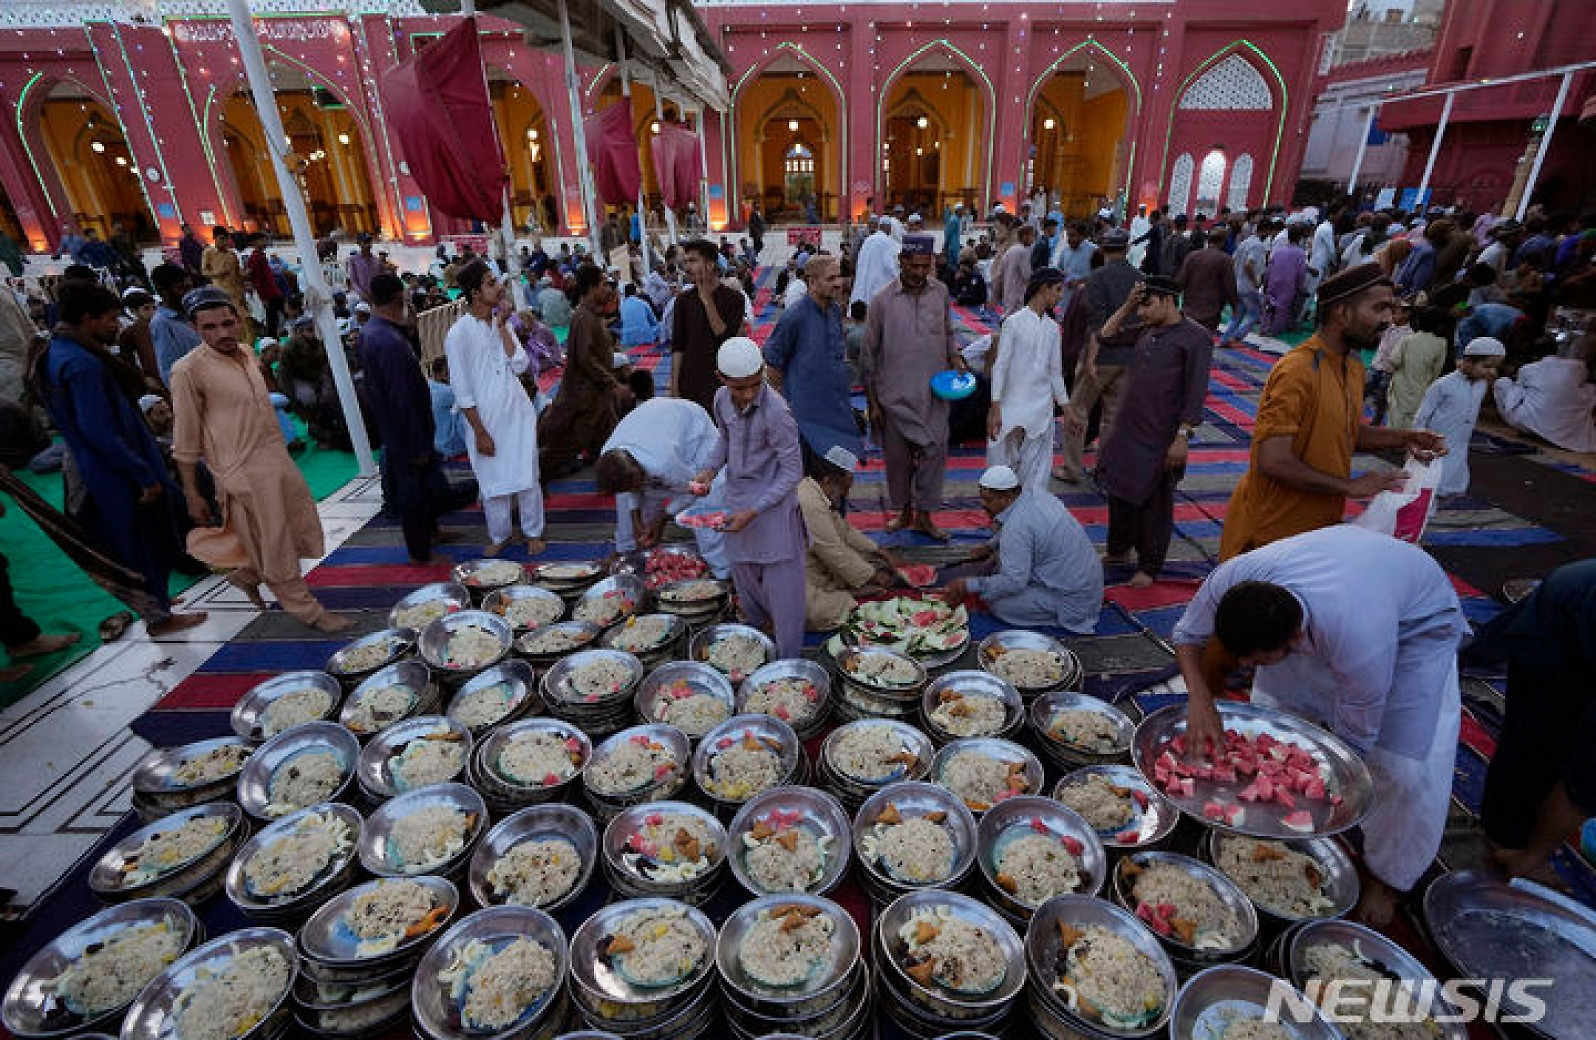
<box><xmin>121</xmin><ymin>928</ymin><xmax>298</xmax><ymax>1040</ymax></box>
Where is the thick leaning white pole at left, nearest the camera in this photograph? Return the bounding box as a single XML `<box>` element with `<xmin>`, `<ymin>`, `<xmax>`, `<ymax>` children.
<box><xmin>227</xmin><ymin>0</ymin><xmax>377</xmax><ymax>477</ymax></box>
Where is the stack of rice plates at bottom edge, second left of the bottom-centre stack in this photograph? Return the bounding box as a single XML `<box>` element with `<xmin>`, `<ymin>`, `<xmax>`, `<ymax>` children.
<box><xmin>410</xmin><ymin>906</ymin><xmax>570</xmax><ymax>1040</ymax></box>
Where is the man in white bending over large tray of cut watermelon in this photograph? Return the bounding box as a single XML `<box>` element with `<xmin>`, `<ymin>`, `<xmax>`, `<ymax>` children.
<box><xmin>1173</xmin><ymin>523</ymin><xmax>1468</xmax><ymax>927</ymax></box>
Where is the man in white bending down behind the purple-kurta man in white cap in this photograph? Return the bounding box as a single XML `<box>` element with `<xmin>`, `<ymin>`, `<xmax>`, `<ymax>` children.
<box><xmin>595</xmin><ymin>397</ymin><xmax>731</xmax><ymax>577</ymax></box>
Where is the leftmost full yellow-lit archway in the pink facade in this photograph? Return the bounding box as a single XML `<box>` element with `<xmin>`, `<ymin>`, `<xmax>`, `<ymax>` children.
<box><xmin>38</xmin><ymin>80</ymin><xmax>160</xmax><ymax>242</ymax></box>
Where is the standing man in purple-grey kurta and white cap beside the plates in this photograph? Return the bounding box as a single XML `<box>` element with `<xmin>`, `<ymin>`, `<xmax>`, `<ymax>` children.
<box><xmin>691</xmin><ymin>337</ymin><xmax>809</xmax><ymax>657</ymax></box>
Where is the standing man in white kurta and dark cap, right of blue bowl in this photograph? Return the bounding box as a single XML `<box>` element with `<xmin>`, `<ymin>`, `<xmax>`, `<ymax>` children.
<box><xmin>986</xmin><ymin>268</ymin><xmax>1069</xmax><ymax>488</ymax></box>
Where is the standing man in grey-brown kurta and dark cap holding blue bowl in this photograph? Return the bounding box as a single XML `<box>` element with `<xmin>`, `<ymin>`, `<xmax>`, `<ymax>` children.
<box><xmin>859</xmin><ymin>234</ymin><xmax>966</xmax><ymax>541</ymax></box>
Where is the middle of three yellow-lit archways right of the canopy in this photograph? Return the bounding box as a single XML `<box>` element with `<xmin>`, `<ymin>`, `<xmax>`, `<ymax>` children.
<box><xmin>881</xmin><ymin>49</ymin><xmax>993</xmax><ymax>222</ymax></box>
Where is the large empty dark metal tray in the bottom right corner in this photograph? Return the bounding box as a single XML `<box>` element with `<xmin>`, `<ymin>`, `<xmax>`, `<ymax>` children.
<box><xmin>1424</xmin><ymin>871</ymin><xmax>1596</xmax><ymax>1040</ymax></box>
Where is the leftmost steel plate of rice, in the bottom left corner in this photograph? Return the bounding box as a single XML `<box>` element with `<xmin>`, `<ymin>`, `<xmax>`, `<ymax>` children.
<box><xmin>0</xmin><ymin>898</ymin><xmax>203</xmax><ymax>1040</ymax></box>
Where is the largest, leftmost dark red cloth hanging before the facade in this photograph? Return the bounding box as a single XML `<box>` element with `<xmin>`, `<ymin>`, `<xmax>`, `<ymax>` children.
<box><xmin>383</xmin><ymin>18</ymin><xmax>509</xmax><ymax>223</ymax></box>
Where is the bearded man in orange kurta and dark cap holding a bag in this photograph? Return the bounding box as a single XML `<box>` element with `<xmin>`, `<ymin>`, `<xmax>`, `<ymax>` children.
<box><xmin>1219</xmin><ymin>263</ymin><xmax>1446</xmax><ymax>560</ymax></box>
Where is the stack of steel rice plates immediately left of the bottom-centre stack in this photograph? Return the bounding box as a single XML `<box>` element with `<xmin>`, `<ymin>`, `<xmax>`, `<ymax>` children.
<box><xmin>568</xmin><ymin>898</ymin><xmax>720</xmax><ymax>1040</ymax></box>
